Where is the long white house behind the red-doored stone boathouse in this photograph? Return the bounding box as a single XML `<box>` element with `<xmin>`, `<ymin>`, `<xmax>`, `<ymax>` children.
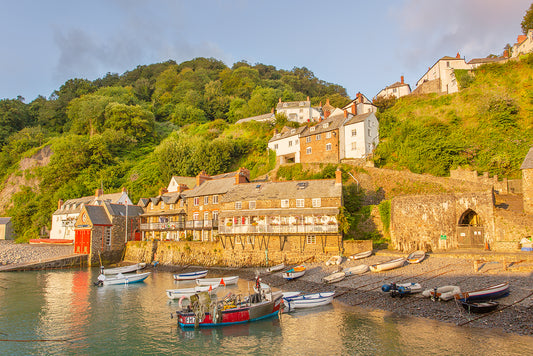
<box><xmin>50</xmin><ymin>189</ymin><xmax>133</xmax><ymax>240</ymax></box>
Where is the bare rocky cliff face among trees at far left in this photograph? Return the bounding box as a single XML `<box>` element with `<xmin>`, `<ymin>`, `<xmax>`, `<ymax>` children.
<box><xmin>0</xmin><ymin>146</ymin><xmax>52</xmax><ymax>215</ymax></box>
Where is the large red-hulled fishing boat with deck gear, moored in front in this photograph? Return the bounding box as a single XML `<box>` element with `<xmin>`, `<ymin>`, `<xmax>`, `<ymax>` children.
<box><xmin>176</xmin><ymin>293</ymin><xmax>282</xmax><ymax>328</ymax></box>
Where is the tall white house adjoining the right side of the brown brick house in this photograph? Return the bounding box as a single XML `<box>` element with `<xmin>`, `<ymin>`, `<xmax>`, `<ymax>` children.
<box><xmin>340</xmin><ymin>112</ymin><xmax>379</xmax><ymax>159</ymax></box>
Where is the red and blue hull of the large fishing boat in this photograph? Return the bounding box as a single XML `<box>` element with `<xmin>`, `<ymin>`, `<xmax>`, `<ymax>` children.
<box><xmin>177</xmin><ymin>296</ymin><xmax>282</xmax><ymax>328</ymax></box>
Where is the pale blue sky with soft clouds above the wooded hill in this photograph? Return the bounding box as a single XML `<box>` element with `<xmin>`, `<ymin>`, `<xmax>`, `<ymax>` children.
<box><xmin>0</xmin><ymin>0</ymin><xmax>532</xmax><ymax>103</ymax></box>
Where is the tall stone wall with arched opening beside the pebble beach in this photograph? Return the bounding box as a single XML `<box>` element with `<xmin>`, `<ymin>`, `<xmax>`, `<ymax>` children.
<box><xmin>390</xmin><ymin>191</ymin><xmax>494</xmax><ymax>251</ymax></box>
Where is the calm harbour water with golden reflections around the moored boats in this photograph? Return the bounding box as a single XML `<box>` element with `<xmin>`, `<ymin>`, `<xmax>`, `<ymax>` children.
<box><xmin>0</xmin><ymin>269</ymin><xmax>533</xmax><ymax>355</ymax></box>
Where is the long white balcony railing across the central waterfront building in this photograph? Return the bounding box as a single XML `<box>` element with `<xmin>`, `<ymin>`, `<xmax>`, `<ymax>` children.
<box><xmin>218</xmin><ymin>224</ymin><xmax>339</xmax><ymax>234</ymax></box>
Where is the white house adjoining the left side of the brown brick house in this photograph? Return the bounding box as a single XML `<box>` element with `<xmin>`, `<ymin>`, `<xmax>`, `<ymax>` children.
<box><xmin>268</xmin><ymin>126</ymin><xmax>307</xmax><ymax>164</ymax></box>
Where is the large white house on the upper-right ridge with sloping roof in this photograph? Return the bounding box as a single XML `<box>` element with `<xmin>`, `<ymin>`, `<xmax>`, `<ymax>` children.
<box><xmin>415</xmin><ymin>53</ymin><xmax>472</xmax><ymax>94</ymax></box>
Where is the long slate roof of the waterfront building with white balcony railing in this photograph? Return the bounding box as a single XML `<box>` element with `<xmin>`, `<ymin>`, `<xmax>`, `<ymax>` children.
<box><xmin>221</xmin><ymin>179</ymin><xmax>342</xmax><ymax>202</ymax></box>
